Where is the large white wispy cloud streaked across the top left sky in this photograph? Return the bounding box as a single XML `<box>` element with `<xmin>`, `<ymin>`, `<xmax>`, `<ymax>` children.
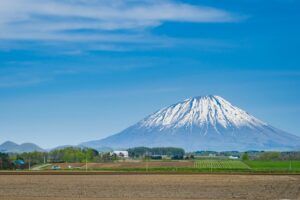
<box><xmin>0</xmin><ymin>0</ymin><xmax>239</xmax><ymax>47</ymax></box>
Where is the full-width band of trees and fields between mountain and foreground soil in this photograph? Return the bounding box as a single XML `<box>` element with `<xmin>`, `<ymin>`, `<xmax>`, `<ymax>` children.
<box><xmin>0</xmin><ymin>147</ymin><xmax>300</xmax><ymax>173</ymax></box>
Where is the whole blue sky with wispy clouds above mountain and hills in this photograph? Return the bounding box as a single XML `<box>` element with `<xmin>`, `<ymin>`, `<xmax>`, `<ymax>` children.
<box><xmin>0</xmin><ymin>0</ymin><xmax>300</xmax><ymax>148</ymax></box>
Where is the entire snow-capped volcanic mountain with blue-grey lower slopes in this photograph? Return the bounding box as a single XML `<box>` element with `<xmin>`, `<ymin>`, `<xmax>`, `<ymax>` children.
<box><xmin>82</xmin><ymin>95</ymin><xmax>300</xmax><ymax>151</ymax></box>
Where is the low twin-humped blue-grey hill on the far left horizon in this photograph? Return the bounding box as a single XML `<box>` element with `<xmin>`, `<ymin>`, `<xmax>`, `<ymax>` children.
<box><xmin>0</xmin><ymin>141</ymin><xmax>45</xmax><ymax>153</ymax></box>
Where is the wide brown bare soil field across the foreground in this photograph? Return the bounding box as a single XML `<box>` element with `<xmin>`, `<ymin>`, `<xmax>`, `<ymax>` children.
<box><xmin>0</xmin><ymin>175</ymin><xmax>300</xmax><ymax>200</ymax></box>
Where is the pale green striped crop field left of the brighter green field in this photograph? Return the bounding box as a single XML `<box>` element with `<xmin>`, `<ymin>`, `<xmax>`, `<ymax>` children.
<box><xmin>194</xmin><ymin>160</ymin><xmax>250</xmax><ymax>170</ymax></box>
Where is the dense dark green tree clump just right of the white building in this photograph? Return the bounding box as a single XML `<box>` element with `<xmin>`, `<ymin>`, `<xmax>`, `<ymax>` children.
<box><xmin>128</xmin><ymin>147</ymin><xmax>185</xmax><ymax>159</ymax></box>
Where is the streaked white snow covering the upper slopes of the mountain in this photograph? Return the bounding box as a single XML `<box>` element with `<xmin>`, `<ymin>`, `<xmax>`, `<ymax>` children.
<box><xmin>139</xmin><ymin>95</ymin><xmax>267</xmax><ymax>130</ymax></box>
